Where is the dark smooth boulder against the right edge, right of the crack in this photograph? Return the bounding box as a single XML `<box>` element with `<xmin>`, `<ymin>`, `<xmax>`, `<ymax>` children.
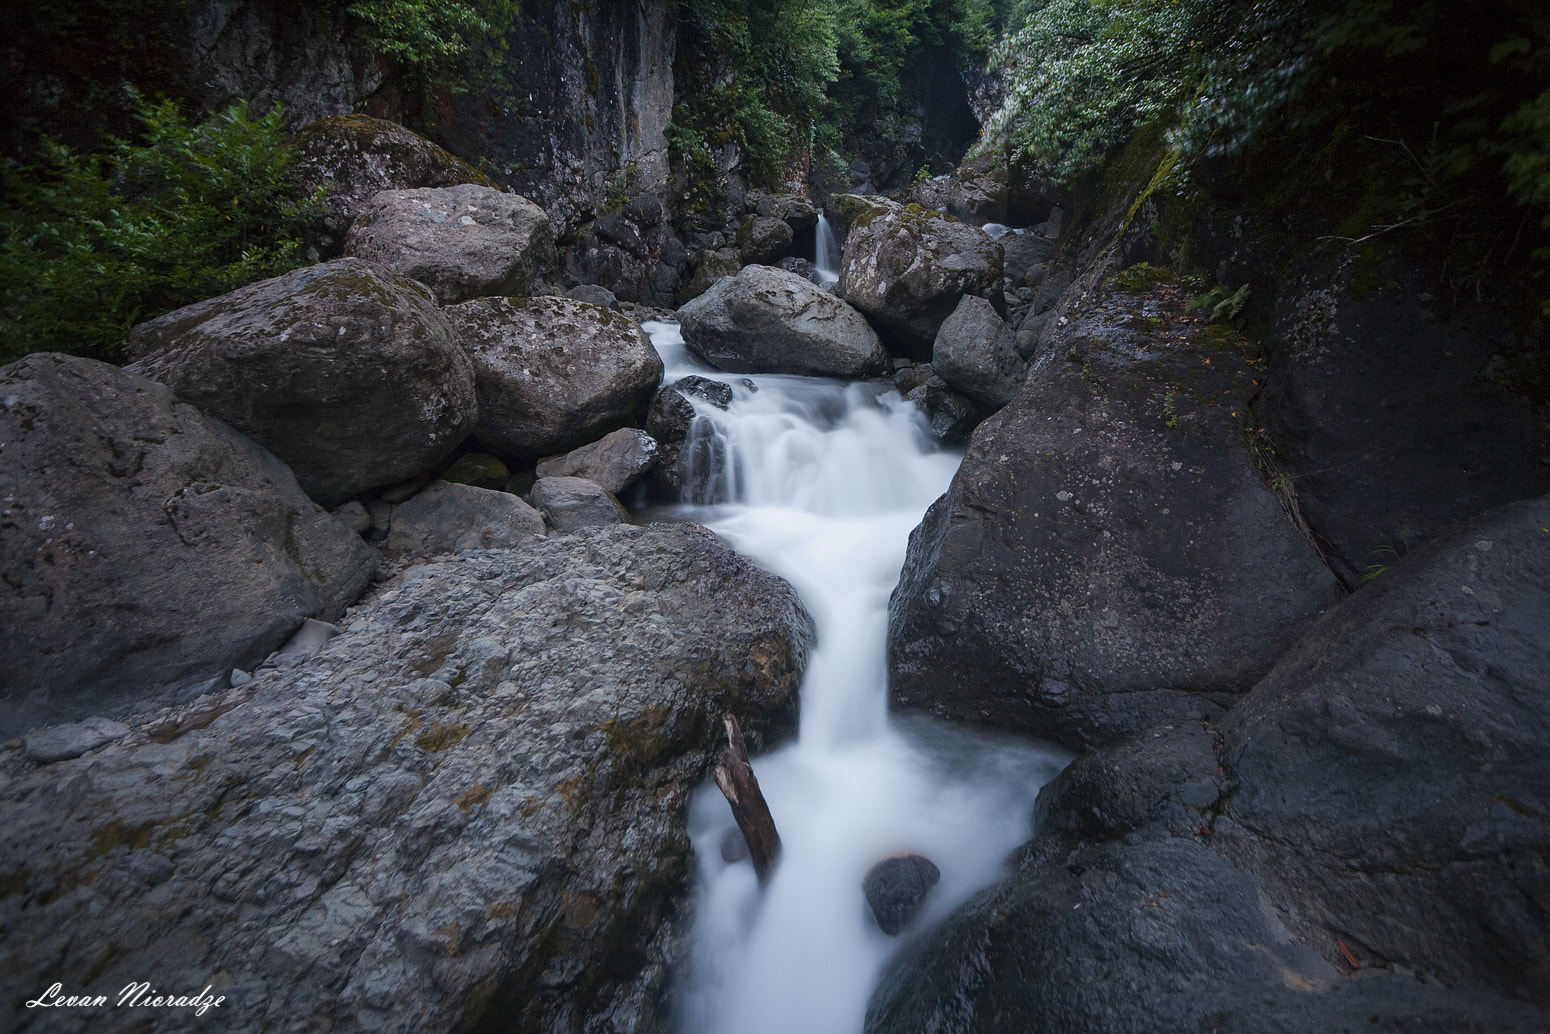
<box><xmin>1221</xmin><ymin>496</ymin><xmax>1550</xmax><ymax>1006</ymax></box>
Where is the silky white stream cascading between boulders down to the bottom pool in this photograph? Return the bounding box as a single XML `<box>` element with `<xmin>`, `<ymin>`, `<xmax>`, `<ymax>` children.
<box><xmin>646</xmin><ymin>322</ymin><xmax>1065</xmax><ymax>1034</ymax></box>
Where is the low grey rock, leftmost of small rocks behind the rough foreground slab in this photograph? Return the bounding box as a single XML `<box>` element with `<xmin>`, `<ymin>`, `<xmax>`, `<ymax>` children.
<box><xmin>386</xmin><ymin>481</ymin><xmax>544</xmax><ymax>557</ymax></box>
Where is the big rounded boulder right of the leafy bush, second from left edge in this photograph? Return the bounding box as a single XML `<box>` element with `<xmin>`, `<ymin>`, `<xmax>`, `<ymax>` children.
<box><xmin>127</xmin><ymin>259</ymin><xmax>474</xmax><ymax>507</ymax></box>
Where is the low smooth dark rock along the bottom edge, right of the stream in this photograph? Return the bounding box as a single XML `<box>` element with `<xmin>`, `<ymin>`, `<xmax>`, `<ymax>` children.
<box><xmin>865</xmin><ymin>837</ymin><xmax>1545</xmax><ymax>1034</ymax></box>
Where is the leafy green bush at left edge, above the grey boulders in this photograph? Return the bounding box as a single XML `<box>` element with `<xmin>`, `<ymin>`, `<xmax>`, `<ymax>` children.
<box><xmin>0</xmin><ymin>101</ymin><xmax>316</xmax><ymax>360</ymax></box>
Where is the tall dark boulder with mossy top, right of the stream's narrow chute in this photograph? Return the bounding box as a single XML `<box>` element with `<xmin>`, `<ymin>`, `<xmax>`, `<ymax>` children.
<box><xmin>888</xmin><ymin>274</ymin><xmax>1338</xmax><ymax>746</ymax></box>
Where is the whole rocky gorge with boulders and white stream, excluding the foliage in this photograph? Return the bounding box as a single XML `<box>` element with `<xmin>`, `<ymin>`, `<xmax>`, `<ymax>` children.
<box><xmin>0</xmin><ymin>3</ymin><xmax>1550</xmax><ymax>1034</ymax></box>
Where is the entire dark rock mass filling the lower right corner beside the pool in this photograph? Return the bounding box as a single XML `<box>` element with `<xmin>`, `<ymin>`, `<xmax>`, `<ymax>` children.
<box><xmin>866</xmin><ymin>498</ymin><xmax>1550</xmax><ymax>1034</ymax></box>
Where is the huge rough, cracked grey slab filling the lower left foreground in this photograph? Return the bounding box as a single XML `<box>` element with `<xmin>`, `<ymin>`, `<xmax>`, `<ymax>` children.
<box><xmin>0</xmin><ymin>527</ymin><xmax>812</xmax><ymax>1034</ymax></box>
